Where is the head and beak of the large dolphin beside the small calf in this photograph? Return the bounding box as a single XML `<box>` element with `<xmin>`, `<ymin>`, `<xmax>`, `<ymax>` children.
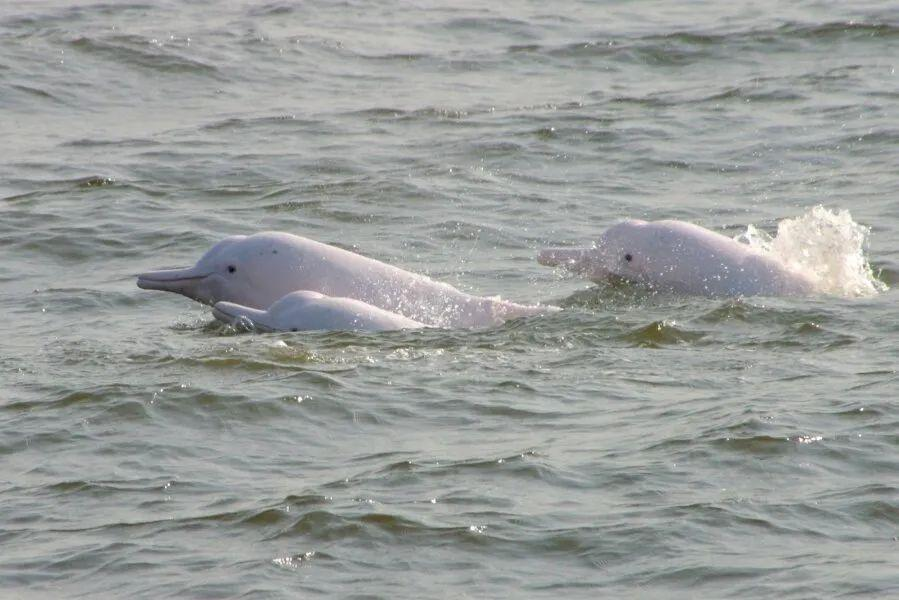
<box><xmin>137</xmin><ymin>233</ymin><xmax>299</xmax><ymax>308</ymax></box>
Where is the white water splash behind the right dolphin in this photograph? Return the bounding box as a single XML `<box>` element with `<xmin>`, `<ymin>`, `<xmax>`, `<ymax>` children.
<box><xmin>735</xmin><ymin>205</ymin><xmax>888</xmax><ymax>298</ymax></box>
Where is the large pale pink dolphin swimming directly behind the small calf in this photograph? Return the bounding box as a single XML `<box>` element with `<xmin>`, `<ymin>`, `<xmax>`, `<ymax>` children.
<box><xmin>137</xmin><ymin>231</ymin><xmax>559</xmax><ymax>328</ymax></box>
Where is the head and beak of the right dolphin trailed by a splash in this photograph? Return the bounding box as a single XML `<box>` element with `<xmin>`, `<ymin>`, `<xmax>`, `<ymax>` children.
<box><xmin>537</xmin><ymin>219</ymin><xmax>654</xmax><ymax>282</ymax></box>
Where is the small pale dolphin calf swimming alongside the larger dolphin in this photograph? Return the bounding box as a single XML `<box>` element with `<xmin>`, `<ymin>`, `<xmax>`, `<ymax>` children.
<box><xmin>212</xmin><ymin>290</ymin><xmax>425</xmax><ymax>331</ymax></box>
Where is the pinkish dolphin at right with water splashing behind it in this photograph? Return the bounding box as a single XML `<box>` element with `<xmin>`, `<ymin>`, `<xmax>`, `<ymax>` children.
<box><xmin>537</xmin><ymin>219</ymin><xmax>815</xmax><ymax>297</ymax></box>
